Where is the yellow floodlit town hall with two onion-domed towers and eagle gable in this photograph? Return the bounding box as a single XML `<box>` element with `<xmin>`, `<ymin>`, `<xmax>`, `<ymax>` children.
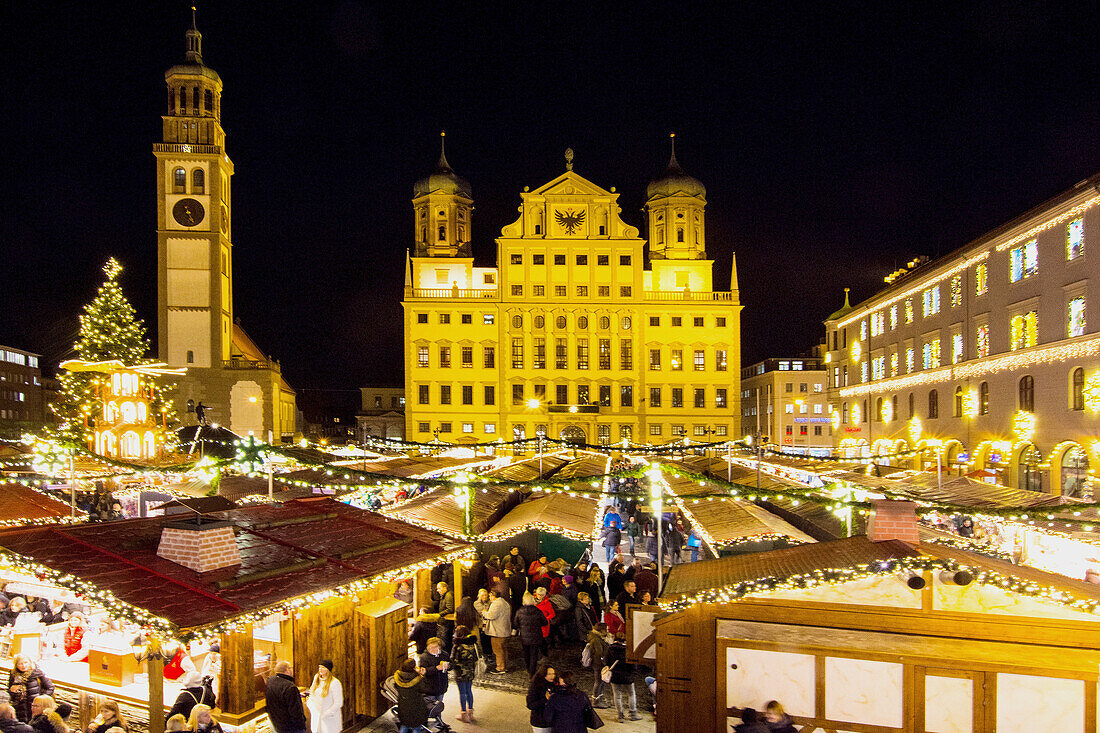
<box><xmin>402</xmin><ymin>138</ymin><xmax>741</xmax><ymax>445</ymax></box>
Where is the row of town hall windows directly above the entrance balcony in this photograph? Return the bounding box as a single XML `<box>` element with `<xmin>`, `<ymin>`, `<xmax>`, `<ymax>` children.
<box><xmin>417</xmin><ymin>384</ymin><xmax>729</xmax><ymax>409</ymax></box>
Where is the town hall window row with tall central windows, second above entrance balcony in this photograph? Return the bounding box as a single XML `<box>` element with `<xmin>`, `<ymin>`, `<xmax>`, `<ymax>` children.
<box><xmin>416</xmin><ymin>337</ymin><xmax>728</xmax><ymax>372</ymax></box>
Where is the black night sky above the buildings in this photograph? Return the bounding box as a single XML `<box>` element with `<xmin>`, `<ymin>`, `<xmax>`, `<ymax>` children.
<box><xmin>8</xmin><ymin>0</ymin><xmax>1100</xmax><ymax>387</ymax></box>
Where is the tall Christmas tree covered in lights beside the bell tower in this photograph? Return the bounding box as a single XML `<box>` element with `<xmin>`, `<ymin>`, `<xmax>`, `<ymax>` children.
<box><xmin>53</xmin><ymin>258</ymin><xmax>175</xmax><ymax>446</ymax></box>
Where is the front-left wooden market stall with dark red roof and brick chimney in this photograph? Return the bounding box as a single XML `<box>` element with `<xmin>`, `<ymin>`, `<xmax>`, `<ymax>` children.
<box><xmin>0</xmin><ymin>497</ymin><xmax>472</xmax><ymax>733</ymax></box>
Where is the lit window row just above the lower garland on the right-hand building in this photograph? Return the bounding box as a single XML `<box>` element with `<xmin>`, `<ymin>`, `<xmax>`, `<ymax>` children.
<box><xmin>833</xmin><ymin>296</ymin><xmax>1086</xmax><ymax>386</ymax></box>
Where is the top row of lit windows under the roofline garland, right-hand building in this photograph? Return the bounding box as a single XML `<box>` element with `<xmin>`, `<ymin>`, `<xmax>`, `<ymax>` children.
<box><xmin>833</xmin><ymin>218</ymin><xmax>1085</xmax><ymax>351</ymax></box>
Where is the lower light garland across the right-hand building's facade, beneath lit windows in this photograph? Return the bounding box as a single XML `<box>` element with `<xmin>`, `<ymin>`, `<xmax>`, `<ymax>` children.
<box><xmin>840</xmin><ymin>336</ymin><xmax>1100</xmax><ymax>400</ymax></box>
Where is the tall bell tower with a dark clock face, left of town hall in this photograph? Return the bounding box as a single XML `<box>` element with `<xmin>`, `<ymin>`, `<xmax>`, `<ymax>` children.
<box><xmin>153</xmin><ymin>7</ymin><xmax>233</xmax><ymax>369</ymax></box>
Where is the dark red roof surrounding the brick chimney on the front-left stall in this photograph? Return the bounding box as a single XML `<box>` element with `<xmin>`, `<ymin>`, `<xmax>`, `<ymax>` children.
<box><xmin>0</xmin><ymin>497</ymin><xmax>468</xmax><ymax>628</ymax></box>
